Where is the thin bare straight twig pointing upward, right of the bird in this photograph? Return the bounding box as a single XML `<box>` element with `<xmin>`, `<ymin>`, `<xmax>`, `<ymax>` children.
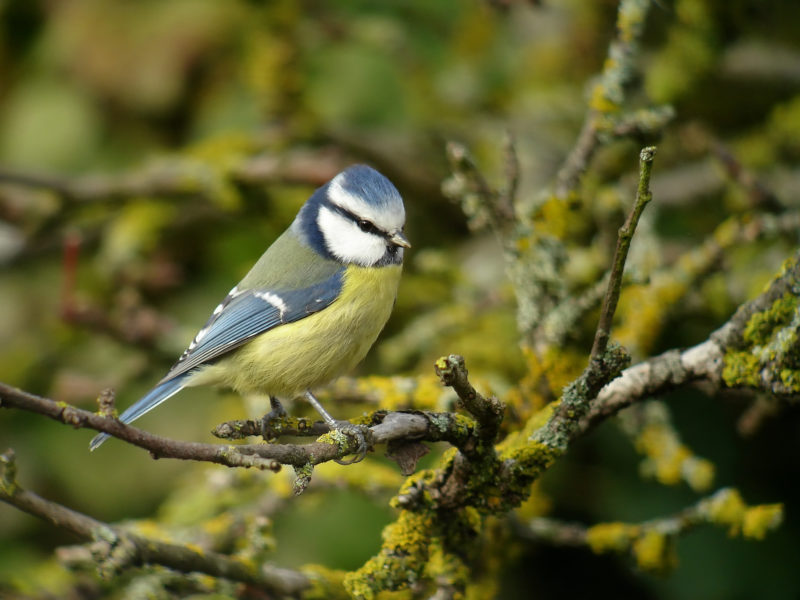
<box><xmin>589</xmin><ymin>146</ymin><xmax>656</xmax><ymax>362</ymax></box>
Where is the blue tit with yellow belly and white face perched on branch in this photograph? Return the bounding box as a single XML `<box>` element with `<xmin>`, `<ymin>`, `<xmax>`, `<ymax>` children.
<box><xmin>89</xmin><ymin>165</ymin><xmax>411</xmax><ymax>462</ymax></box>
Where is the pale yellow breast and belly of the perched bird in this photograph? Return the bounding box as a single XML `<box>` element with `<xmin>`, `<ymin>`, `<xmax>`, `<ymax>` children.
<box><xmin>187</xmin><ymin>265</ymin><xmax>402</xmax><ymax>397</ymax></box>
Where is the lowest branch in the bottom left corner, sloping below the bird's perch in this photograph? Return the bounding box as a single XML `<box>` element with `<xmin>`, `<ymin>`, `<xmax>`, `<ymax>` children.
<box><xmin>0</xmin><ymin>450</ymin><xmax>311</xmax><ymax>597</ymax></box>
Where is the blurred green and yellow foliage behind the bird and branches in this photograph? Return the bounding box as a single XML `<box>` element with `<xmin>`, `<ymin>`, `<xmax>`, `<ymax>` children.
<box><xmin>0</xmin><ymin>0</ymin><xmax>800</xmax><ymax>599</ymax></box>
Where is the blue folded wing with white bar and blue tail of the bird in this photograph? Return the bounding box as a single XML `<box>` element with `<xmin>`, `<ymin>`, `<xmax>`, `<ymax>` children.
<box><xmin>89</xmin><ymin>268</ymin><xmax>344</xmax><ymax>450</ymax></box>
